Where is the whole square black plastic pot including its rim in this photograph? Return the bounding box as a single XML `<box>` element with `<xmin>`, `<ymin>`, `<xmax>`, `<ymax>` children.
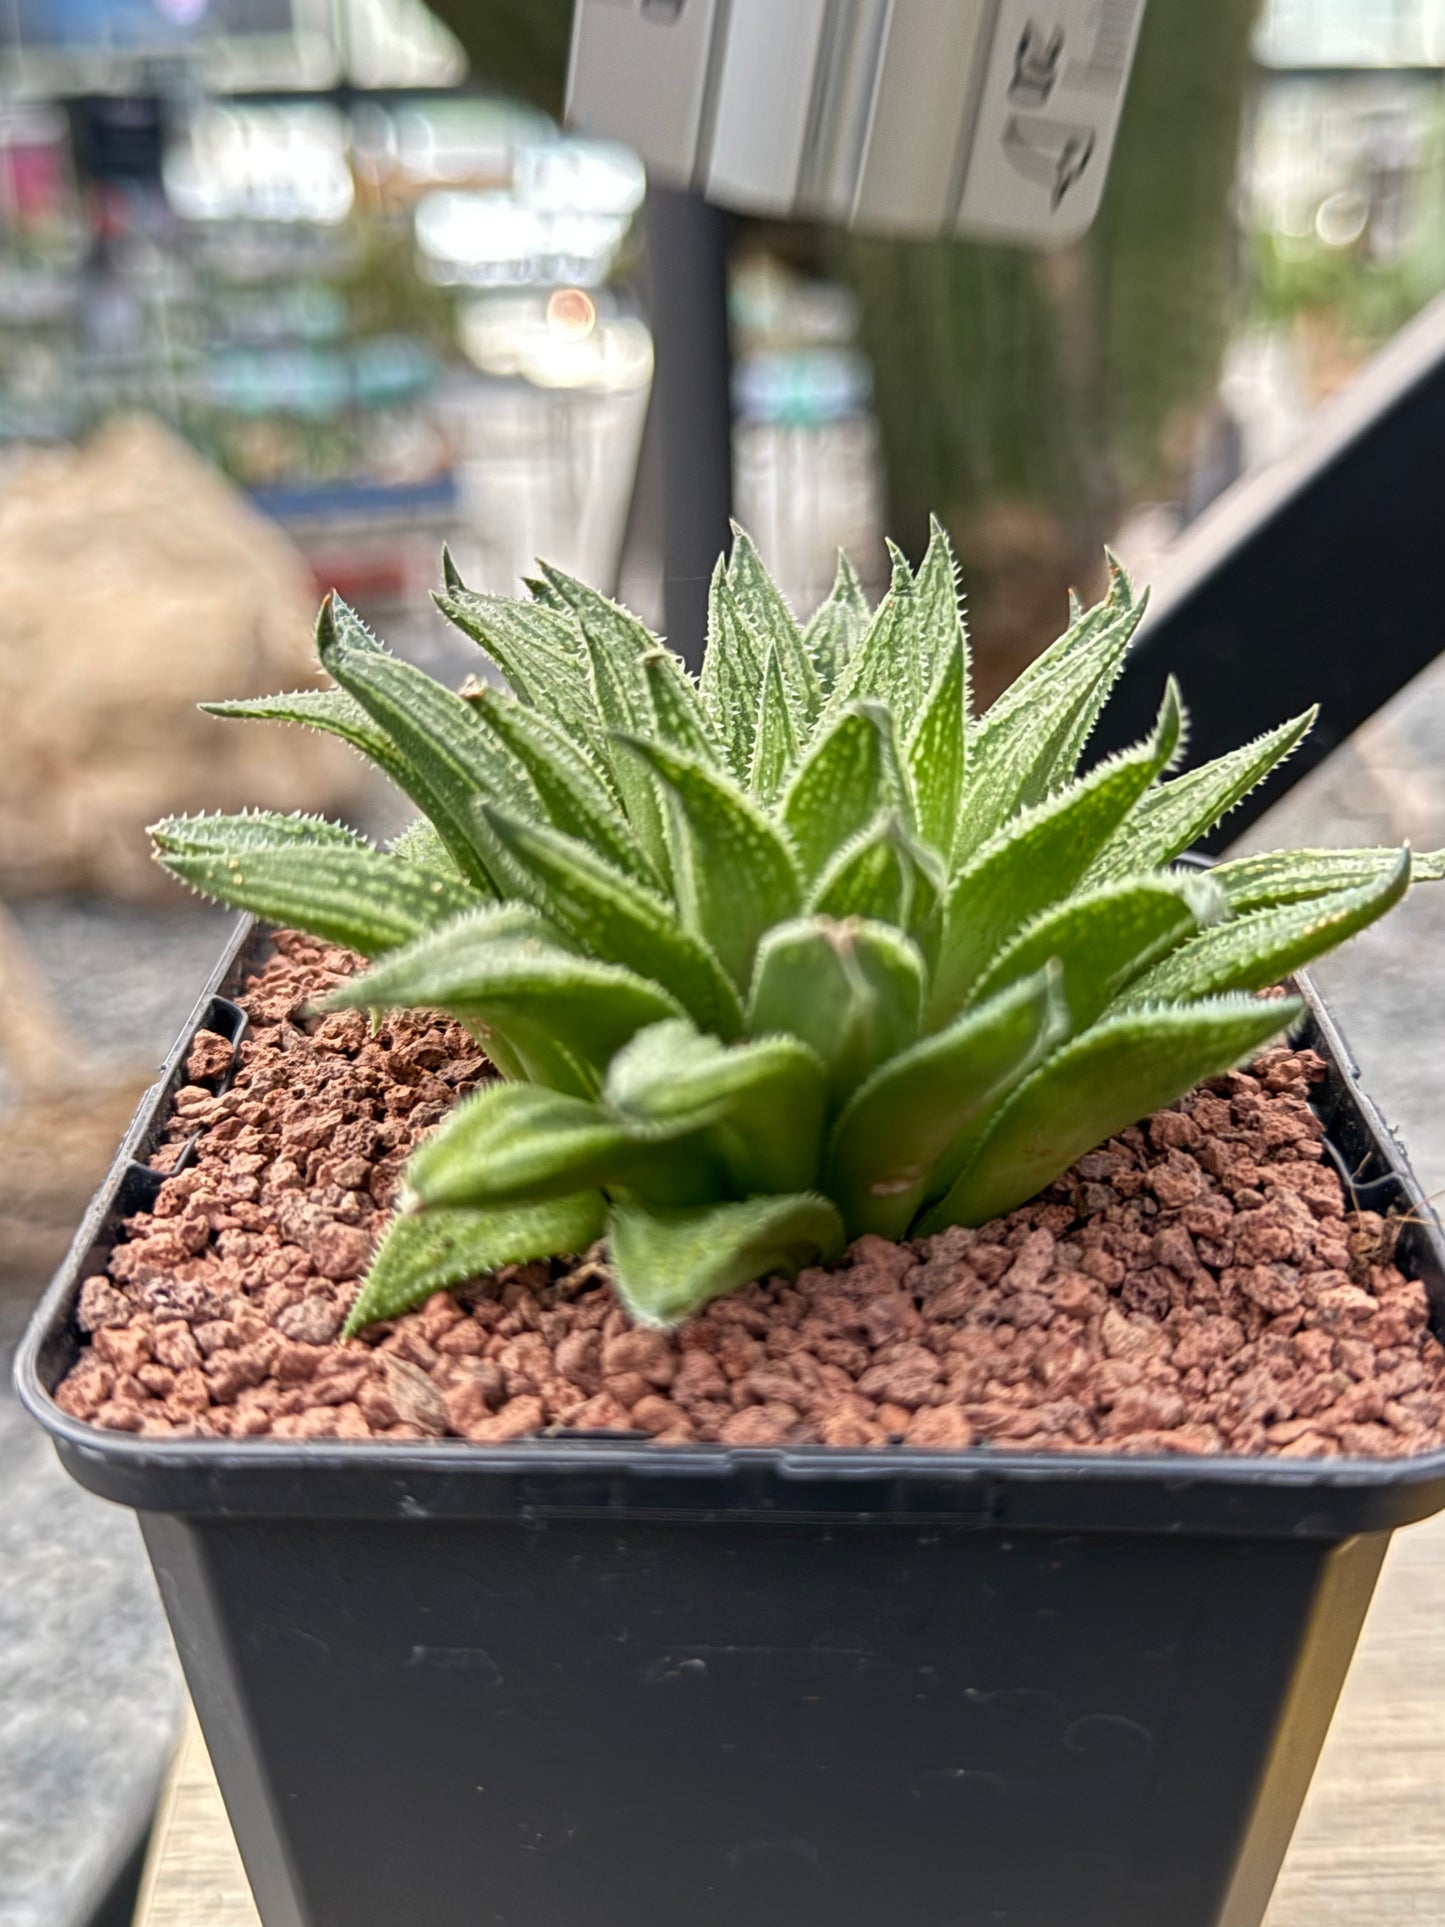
<box><xmin>19</xmin><ymin>925</ymin><xmax>1445</xmax><ymax>1927</ymax></box>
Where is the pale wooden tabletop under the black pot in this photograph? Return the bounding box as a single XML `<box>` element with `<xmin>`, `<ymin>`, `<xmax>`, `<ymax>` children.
<box><xmin>135</xmin><ymin>1515</ymin><xmax>1445</xmax><ymax>1927</ymax></box>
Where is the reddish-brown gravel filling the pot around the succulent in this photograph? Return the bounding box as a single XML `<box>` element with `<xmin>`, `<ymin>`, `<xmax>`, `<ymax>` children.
<box><xmin>56</xmin><ymin>933</ymin><xmax>1445</xmax><ymax>1457</ymax></box>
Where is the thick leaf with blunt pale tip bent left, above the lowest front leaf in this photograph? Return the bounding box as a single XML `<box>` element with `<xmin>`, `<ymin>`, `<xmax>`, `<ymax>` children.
<box><xmin>603</xmin><ymin>1021</ymin><xmax>825</xmax><ymax>1197</ymax></box>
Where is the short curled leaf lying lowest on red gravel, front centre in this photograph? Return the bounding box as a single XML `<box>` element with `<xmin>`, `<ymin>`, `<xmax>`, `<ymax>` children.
<box><xmin>607</xmin><ymin>1191</ymin><xmax>842</xmax><ymax>1326</ymax></box>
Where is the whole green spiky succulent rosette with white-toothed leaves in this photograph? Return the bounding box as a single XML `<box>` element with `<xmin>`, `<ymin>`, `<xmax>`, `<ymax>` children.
<box><xmin>154</xmin><ymin>524</ymin><xmax>1445</xmax><ymax>1330</ymax></box>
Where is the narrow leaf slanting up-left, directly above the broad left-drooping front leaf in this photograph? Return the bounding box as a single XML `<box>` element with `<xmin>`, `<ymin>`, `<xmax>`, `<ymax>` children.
<box><xmin>486</xmin><ymin>809</ymin><xmax>742</xmax><ymax>1037</ymax></box>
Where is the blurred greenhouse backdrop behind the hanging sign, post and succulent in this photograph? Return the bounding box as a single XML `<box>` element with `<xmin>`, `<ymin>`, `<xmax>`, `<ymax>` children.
<box><xmin>0</xmin><ymin>0</ymin><xmax>1445</xmax><ymax>665</ymax></box>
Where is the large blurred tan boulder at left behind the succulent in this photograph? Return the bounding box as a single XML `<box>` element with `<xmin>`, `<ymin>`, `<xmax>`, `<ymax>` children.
<box><xmin>0</xmin><ymin>416</ymin><xmax>366</xmax><ymax>900</ymax></box>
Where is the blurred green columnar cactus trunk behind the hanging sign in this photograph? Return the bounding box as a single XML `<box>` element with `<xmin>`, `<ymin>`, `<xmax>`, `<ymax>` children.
<box><xmin>828</xmin><ymin>0</ymin><xmax>1258</xmax><ymax>688</ymax></box>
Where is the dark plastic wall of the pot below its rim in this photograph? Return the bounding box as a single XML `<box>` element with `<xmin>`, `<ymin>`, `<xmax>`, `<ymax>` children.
<box><xmin>145</xmin><ymin>1515</ymin><xmax>1387</xmax><ymax>1927</ymax></box>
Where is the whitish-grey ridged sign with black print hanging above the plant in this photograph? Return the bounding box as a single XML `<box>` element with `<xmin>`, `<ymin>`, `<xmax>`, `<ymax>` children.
<box><xmin>568</xmin><ymin>0</ymin><xmax>1144</xmax><ymax>247</ymax></box>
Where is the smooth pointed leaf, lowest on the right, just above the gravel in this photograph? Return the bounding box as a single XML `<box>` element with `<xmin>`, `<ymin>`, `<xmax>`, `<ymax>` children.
<box><xmin>932</xmin><ymin>996</ymin><xmax>1304</xmax><ymax>1235</ymax></box>
